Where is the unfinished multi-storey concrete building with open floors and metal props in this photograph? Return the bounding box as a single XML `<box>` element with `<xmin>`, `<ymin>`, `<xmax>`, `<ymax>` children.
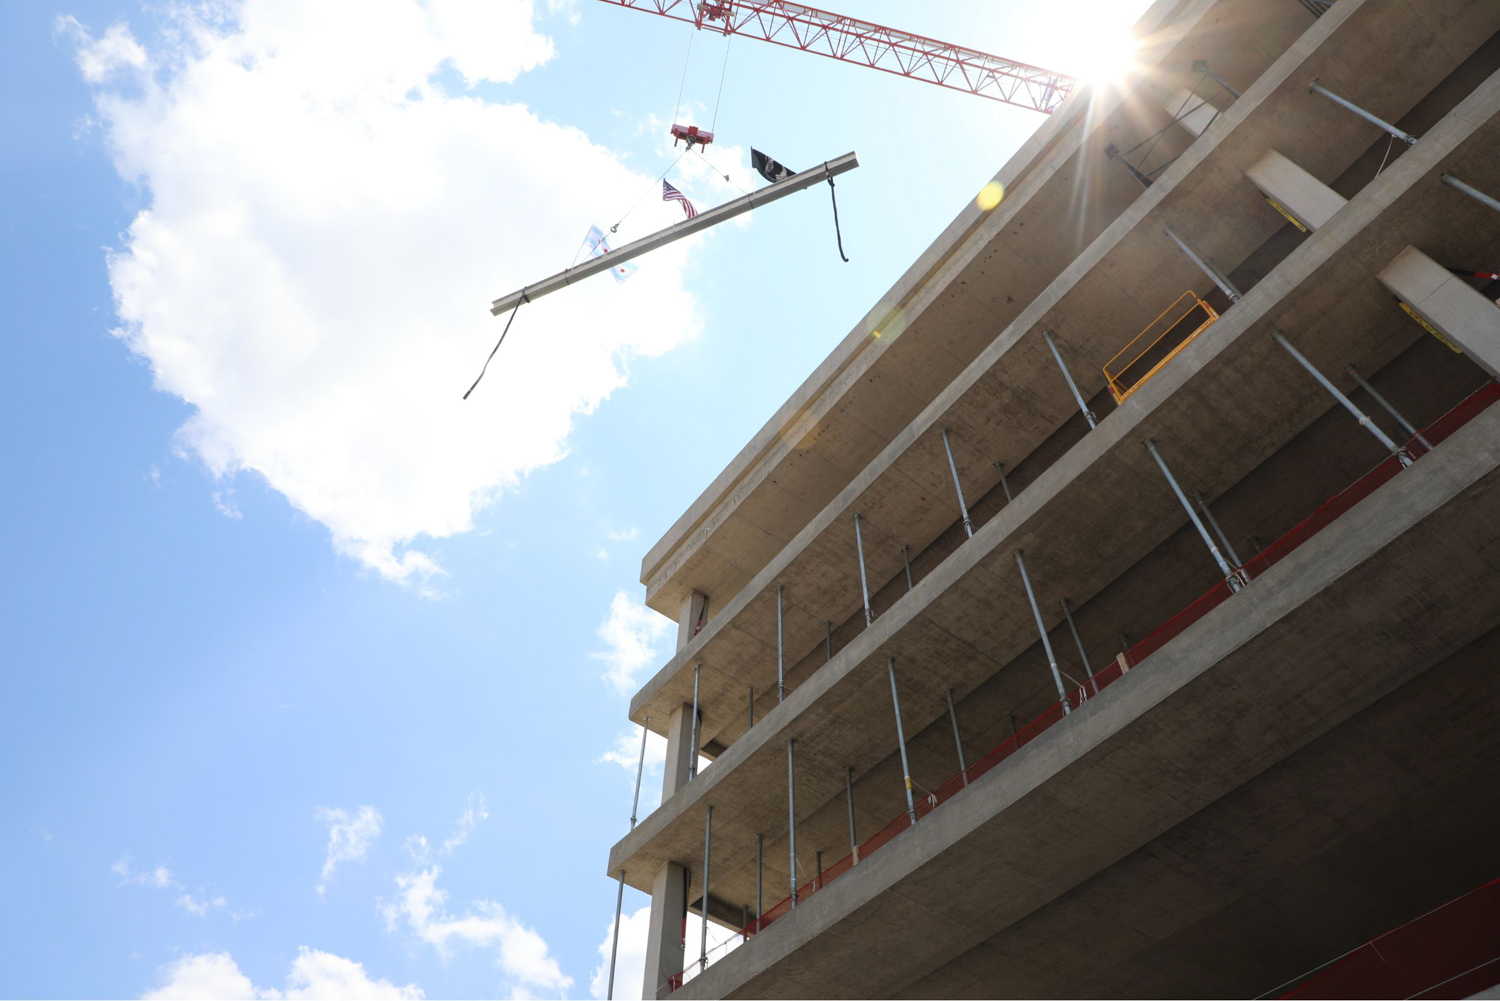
<box><xmin>608</xmin><ymin>0</ymin><xmax>1500</xmax><ymax>998</ymax></box>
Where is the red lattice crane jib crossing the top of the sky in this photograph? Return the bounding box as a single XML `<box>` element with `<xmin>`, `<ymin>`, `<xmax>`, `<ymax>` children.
<box><xmin>602</xmin><ymin>0</ymin><xmax>1077</xmax><ymax>114</ymax></box>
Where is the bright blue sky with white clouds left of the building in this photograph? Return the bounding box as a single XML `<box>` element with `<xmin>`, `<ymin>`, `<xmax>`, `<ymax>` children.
<box><xmin>0</xmin><ymin>0</ymin><xmax>1146</xmax><ymax>998</ymax></box>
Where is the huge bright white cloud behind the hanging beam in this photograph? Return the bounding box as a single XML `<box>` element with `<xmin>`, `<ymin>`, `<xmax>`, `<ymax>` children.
<box><xmin>60</xmin><ymin>0</ymin><xmax>710</xmax><ymax>581</ymax></box>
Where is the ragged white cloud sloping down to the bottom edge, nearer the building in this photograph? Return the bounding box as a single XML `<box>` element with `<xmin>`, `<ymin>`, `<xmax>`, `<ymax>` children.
<box><xmin>381</xmin><ymin>866</ymin><xmax>573</xmax><ymax>990</ymax></box>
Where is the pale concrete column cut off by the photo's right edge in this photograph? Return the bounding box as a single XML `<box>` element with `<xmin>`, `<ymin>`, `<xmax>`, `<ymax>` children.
<box><xmin>1380</xmin><ymin>246</ymin><xmax>1500</xmax><ymax>375</ymax></box>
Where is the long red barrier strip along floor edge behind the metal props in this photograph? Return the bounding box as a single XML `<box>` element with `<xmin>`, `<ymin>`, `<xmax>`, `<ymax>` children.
<box><xmin>669</xmin><ymin>381</ymin><xmax>1500</xmax><ymax>996</ymax></box>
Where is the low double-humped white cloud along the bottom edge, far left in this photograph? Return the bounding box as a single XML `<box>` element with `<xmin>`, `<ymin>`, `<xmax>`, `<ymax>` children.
<box><xmin>141</xmin><ymin>945</ymin><xmax>423</xmax><ymax>999</ymax></box>
